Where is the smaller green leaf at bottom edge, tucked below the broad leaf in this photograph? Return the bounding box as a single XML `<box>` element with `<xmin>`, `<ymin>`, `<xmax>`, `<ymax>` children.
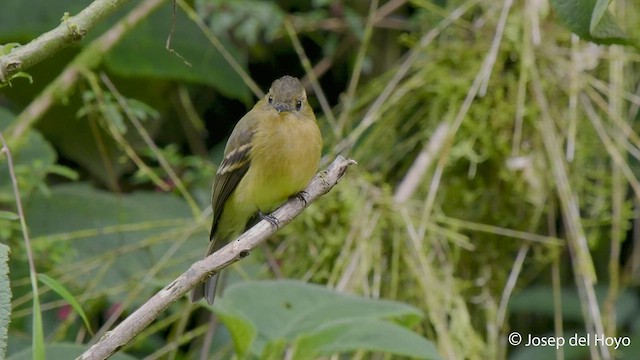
<box><xmin>292</xmin><ymin>319</ymin><xmax>441</xmax><ymax>359</ymax></box>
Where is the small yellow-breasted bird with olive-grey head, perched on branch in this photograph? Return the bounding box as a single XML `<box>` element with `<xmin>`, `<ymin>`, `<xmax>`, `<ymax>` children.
<box><xmin>191</xmin><ymin>76</ymin><xmax>322</xmax><ymax>304</ymax></box>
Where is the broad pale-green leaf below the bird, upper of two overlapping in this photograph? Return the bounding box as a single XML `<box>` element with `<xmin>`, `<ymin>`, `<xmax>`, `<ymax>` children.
<box><xmin>214</xmin><ymin>280</ymin><xmax>430</xmax><ymax>356</ymax></box>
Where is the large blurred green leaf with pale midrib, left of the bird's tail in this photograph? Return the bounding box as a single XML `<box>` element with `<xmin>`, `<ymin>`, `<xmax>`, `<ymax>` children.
<box><xmin>26</xmin><ymin>183</ymin><xmax>200</xmax><ymax>300</ymax></box>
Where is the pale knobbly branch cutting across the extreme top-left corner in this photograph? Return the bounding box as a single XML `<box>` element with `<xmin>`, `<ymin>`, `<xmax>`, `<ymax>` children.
<box><xmin>0</xmin><ymin>0</ymin><xmax>130</xmax><ymax>83</ymax></box>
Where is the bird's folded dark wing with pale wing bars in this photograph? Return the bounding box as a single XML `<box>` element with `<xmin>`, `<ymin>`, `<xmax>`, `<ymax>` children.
<box><xmin>209</xmin><ymin>112</ymin><xmax>256</xmax><ymax>240</ymax></box>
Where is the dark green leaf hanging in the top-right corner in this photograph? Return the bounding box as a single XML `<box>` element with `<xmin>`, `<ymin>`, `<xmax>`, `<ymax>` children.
<box><xmin>551</xmin><ymin>0</ymin><xmax>634</xmax><ymax>45</ymax></box>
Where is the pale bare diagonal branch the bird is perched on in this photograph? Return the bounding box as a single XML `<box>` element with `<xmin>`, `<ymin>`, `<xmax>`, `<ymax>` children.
<box><xmin>78</xmin><ymin>156</ymin><xmax>356</xmax><ymax>360</ymax></box>
